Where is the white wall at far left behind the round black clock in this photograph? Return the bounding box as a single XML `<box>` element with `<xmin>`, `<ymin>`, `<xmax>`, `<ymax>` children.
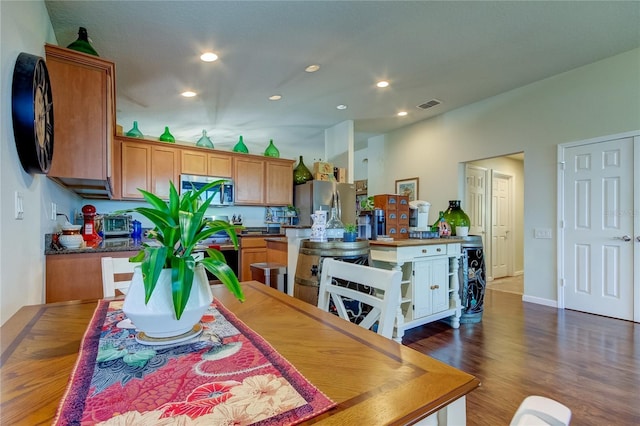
<box><xmin>0</xmin><ymin>1</ymin><xmax>79</xmax><ymax>324</ymax></box>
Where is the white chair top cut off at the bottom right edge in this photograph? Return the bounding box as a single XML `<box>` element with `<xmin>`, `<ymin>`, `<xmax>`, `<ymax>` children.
<box><xmin>510</xmin><ymin>395</ymin><xmax>571</xmax><ymax>426</ymax></box>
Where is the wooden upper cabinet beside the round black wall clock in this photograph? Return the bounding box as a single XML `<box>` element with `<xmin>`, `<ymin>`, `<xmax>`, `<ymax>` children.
<box><xmin>45</xmin><ymin>44</ymin><xmax>115</xmax><ymax>198</ymax></box>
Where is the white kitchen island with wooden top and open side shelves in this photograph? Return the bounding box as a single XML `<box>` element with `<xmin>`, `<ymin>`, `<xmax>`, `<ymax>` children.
<box><xmin>370</xmin><ymin>237</ymin><xmax>464</xmax><ymax>342</ymax></box>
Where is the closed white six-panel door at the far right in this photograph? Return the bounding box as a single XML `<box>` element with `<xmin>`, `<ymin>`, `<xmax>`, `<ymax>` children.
<box><xmin>561</xmin><ymin>137</ymin><xmax>640</xmax><ymax>321</ymax></box>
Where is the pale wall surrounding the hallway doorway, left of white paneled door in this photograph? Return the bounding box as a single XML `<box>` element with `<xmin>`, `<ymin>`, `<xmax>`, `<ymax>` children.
<box><xmin>380</xmin><ymin>49</ymin><xmax>640</xmax><ymax>302</ymax></box>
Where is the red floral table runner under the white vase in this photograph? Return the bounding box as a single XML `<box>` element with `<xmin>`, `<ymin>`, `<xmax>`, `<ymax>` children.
<box><xmin>54</xmin><ymin>300</ymin><xmax>336</xmax><ymax>425</ymax></box>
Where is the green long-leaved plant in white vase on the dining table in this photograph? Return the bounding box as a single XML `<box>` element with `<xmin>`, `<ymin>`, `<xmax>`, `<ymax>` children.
<box><xmin>123</xmin><ymin>182</ymin><xmax>244</xmax><ymax>338</ymax></box>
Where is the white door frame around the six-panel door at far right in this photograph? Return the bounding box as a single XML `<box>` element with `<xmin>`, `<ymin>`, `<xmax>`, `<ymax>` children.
<box><xmin>556</xmin><ymin>130</ymin><xmax>640</xmax><ymax>322</ymax></box>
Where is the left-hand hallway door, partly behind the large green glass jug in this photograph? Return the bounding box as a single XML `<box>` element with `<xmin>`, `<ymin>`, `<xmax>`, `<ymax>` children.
<box><xmin>464</xmin><ymin>164</ymin><xmax>487</xmax><ymax>241</ymax></box>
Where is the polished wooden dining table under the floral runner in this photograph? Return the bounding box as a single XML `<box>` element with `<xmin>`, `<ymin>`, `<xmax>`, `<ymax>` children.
<box><xmin>0</xmin><ymin>281</ymin><xmax>480</xmax><ymax>426</ymax></box>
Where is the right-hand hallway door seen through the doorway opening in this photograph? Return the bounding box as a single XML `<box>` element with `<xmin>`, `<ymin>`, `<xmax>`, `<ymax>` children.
<box><xmin>491</xmin><ymin>171</ymin><xmax>513</xmax><ymax>279</ymax></box>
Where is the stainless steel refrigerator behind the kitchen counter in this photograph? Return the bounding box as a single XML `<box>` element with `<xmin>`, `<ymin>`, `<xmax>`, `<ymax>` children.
<box><xmin>293</xmin><ymin>180</ymin><xmax>357</xmax><ymax>226</ymax></box>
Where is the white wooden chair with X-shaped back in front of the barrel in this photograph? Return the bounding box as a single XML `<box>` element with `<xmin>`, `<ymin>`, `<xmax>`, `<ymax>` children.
<box><xmin>318</xmin><ymin>258</ymin><xmax>402</xmax><ymax>339</ymax></box>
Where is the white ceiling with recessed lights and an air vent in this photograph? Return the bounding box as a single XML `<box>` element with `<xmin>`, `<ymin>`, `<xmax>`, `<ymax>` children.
<box><xmin>45</xmin><ymin>0</ymin><xmax>640</xmax><ymax>157</ymax></box>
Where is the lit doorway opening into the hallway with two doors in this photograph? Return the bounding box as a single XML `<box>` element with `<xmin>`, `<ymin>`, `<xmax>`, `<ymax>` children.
<box><xmin>462</xmin><ymin>152</ymin><xmax>524</xmax><ymax>294</ymax></box>
